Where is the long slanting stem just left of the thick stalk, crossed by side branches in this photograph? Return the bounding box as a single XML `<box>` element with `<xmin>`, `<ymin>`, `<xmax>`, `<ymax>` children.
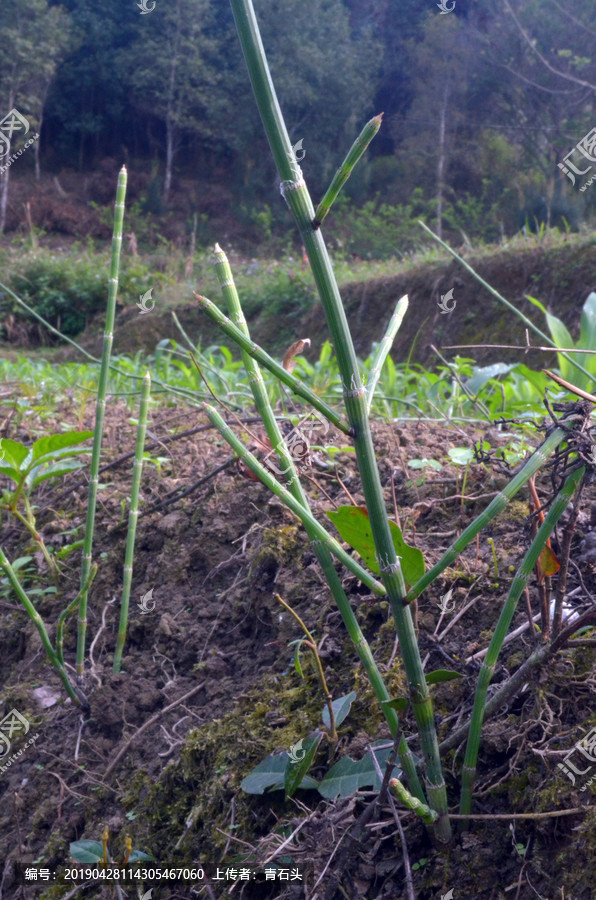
<box><xmin>215</xmin><ymin>244</ymin><xmax>424</xmax><ymax>799</ymax></box>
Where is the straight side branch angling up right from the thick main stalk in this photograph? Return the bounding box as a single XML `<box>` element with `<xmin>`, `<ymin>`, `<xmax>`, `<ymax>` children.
<box><xmin>406</xmin><ymin>428</ymin><xmax>565</xmax><ymax>603</ymax></box>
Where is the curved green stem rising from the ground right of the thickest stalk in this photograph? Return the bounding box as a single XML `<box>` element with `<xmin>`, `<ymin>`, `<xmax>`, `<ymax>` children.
<box><xmin>459</xmin><ymin>468</ymin><xmax>585</xmax><ymax>815</ymax></box>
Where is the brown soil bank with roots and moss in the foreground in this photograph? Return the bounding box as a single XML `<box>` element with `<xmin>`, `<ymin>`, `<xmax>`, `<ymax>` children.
<box><xmin>0</xmin><ymin>403</ymin><xmax>596</xmax><ymax>900</ymax></box>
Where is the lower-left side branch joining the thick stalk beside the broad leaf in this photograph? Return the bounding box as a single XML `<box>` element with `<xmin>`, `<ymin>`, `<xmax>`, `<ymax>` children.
<box><xmin>203</xmin><ymin>403</ymin><xmax>386</xmax><ymax>597</ymax></box>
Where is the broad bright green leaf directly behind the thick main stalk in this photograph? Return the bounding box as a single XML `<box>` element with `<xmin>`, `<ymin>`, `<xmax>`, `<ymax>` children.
<box><xmin>327</xmin><ymin>506</ymin><xmax>424</xmax><ymax>587</ymax></box>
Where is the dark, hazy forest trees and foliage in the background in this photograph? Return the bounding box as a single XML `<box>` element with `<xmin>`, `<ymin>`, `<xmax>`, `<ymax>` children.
<box><xmin>0</xmin><ymin>0</ymin><xmax>596</xmax><ymax>246</ymax></box>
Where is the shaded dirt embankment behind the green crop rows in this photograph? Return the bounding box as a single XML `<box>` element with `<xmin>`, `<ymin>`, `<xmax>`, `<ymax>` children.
<box><xmin>60</xmin><ymin>239</ymin><xmax>596</xmax><ymax>368</ymax></box>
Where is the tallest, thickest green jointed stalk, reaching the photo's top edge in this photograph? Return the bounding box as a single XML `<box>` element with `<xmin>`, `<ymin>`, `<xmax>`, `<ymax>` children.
<box><xmin>231</xmin><ymin>0</ymin><xmax>451</xmax><ymax>842</ymax></box>
